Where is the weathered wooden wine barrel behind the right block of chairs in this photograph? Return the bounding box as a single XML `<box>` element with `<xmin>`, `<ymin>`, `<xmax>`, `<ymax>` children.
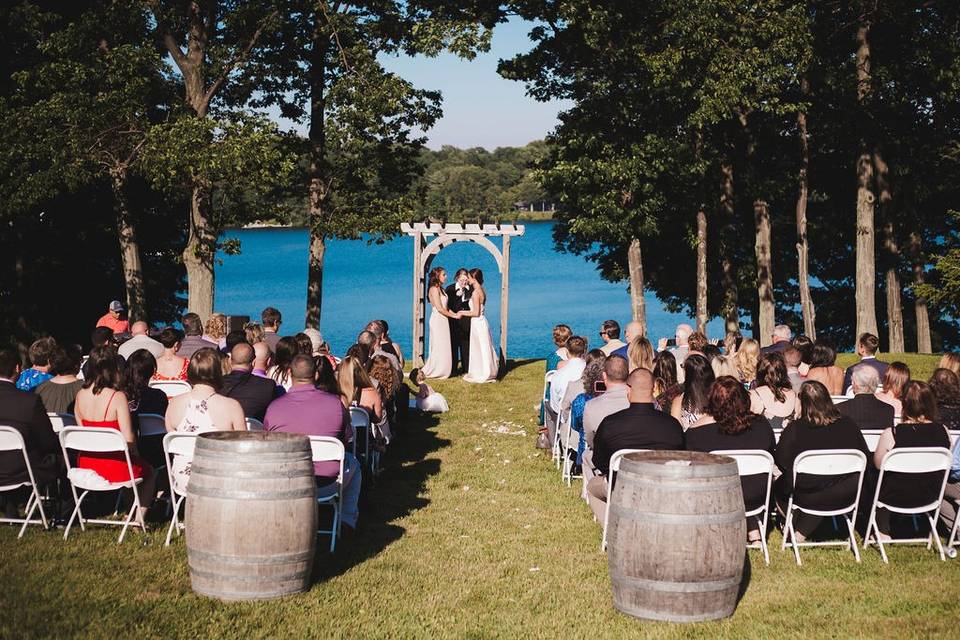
<box><xmin>607</xmin><ymin>451</ymin><xmax>747</xmax><ymax>622</ymax></box>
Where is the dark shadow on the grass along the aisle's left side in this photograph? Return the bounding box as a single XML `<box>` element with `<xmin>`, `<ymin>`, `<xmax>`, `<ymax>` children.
<box><xmin>313</xmin><ymin>411</ymin><xmax>450</xmax><ymax>584</ymax></box>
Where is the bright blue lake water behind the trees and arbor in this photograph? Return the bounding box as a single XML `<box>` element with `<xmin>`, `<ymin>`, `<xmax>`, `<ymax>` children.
<box><xmin>214</xmin><ymin>222</ymin><xmax>723</xmax><ymax>358</ymax></box>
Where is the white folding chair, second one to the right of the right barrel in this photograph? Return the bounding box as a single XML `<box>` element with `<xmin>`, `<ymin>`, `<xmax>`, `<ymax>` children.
<box><xmin>780</xmin><ymin>449</ymin><xmax>867</xmax><ymax>566</ymax></box>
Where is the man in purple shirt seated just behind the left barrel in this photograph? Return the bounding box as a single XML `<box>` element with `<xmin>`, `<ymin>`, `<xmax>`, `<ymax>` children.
<box><xmin>263</xmin><ymin>354</ymin><xmax>360</xmax><ymax>532</ymax></box>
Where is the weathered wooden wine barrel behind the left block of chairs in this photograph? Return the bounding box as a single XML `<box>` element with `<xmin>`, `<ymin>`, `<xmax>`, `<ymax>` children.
<box><xmin>186</xmin><ymin>431</ymin><xmax>317</xmax><ymax>600</ymax></box>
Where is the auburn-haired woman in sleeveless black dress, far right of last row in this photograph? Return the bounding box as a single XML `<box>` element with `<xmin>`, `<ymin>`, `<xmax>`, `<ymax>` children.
<box><xmin>872</xmin><ymin>380</ymin><xmax>950</xmax><ymax>541</ymax></box>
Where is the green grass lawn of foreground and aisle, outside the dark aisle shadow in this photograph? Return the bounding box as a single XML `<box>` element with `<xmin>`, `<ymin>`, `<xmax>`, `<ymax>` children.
<box><xmin>0</xmin><ymin>358</ymin><xmax>960</xmax><ymax>639</ymax></box>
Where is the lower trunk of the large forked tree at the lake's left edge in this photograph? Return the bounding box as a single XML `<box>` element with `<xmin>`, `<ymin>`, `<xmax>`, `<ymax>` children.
<box><xmin>183</xmin><ymin>181</ymin><xmax>217</xmax><ymax>322</ymax></box>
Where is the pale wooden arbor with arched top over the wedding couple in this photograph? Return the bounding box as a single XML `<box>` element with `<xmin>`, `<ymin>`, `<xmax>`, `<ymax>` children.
<box><xmin>400</xmin><ymin>222</ymin><xmax>524</xmax><ymax>369</ymax></box>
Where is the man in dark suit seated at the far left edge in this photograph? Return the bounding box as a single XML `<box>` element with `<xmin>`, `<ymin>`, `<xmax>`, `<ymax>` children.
<box><xmin>0</xmin><ymin>349</ymin><xmax>65</xmax><ymax>486</ymax></box>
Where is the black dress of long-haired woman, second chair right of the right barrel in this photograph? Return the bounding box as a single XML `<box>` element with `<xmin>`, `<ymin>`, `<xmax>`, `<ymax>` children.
<box><xmin>774</xmin><ymin>417</ymin><xmax>872</xmax><ymax>537</ymax></box>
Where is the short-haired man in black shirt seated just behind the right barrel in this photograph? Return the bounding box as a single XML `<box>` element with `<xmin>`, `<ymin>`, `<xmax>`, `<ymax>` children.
<box><xmin>587</xmin><ymin>368</ymin><xmax>688</xmax><ymax>522</ymax></box>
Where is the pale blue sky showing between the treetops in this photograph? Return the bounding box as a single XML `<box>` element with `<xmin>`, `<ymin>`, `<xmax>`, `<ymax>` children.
<box><xmin>270</xmin><ymin>18</ymin><xmax>567</xmax><ymax>150</ymax></box>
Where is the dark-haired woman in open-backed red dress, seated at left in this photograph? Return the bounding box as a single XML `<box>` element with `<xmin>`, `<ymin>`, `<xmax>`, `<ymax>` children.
<box><xmin>74</xmin><ymin>347</ymin><xmax>155</xmax><ymax>518</ymax></box>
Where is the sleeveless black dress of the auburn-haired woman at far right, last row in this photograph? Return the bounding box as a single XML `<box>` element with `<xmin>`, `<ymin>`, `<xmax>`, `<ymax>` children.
<box><xmin>880</xmin><ymin>422</ymin><xmax>950</xmax><ymax>508</ymax></box>
